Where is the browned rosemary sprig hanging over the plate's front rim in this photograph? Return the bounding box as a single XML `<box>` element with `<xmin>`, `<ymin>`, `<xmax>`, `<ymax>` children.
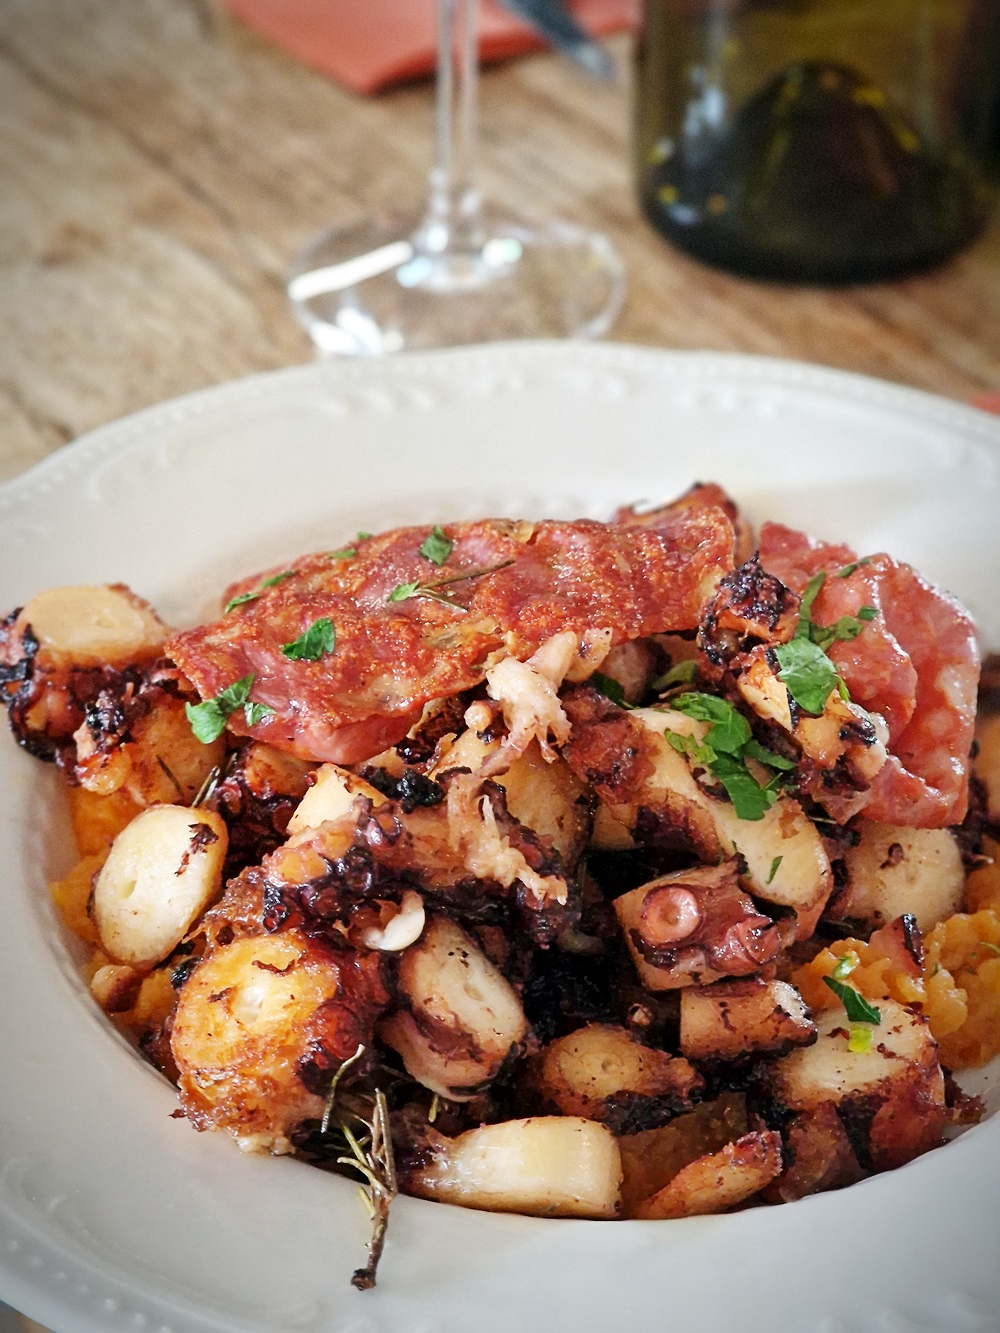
<box><xmin>320</xmin><ymin>1045</ymin><xmax>397</xmax><ymax>1292</ymax></box>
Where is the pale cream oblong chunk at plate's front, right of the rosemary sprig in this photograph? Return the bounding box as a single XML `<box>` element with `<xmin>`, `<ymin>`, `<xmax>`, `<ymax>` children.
<box><xmin>400</xmin><ymin>1116</ymin><xmax>621</xmax><ymax>1218</ymax></box>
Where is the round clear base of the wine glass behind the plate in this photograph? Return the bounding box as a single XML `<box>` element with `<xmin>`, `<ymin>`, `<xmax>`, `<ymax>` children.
<box><xmin>288</xmin><ymin>212</ymin><xmax>625</xmax><ymax>356</ymax></box>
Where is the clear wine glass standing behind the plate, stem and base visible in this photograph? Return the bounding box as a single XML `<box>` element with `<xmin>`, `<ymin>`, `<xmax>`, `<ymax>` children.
<box><xmin>288</xmin><ymin>0</ymin><xmax>625</xmax><ymax>356</ymax></box>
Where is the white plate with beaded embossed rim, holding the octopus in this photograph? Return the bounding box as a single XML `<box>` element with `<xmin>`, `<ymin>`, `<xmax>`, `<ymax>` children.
<box><xmin>0</xmin><ymin>344</ymin><xmax>1000</xmax><ymax>1333</ymax></box>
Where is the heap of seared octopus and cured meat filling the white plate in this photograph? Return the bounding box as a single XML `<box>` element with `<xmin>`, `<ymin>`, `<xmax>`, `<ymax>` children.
<box><xmin>0</xmin><ymin>485</ymin><xmax>1000</xmax><ymax>1274</ymax></box>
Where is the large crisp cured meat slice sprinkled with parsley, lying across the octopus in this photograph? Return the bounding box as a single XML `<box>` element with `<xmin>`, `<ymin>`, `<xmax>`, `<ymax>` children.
<box><xmin>167</xmin><ymin>505</ymin><xmax>733</xmax><ymax>764</ymax></box>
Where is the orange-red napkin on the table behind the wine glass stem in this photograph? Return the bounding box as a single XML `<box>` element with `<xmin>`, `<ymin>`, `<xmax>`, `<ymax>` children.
<box><xmin>221</xmin><ymin>0</ymin><xmax>639</xmax><ymax>92</ymax></box>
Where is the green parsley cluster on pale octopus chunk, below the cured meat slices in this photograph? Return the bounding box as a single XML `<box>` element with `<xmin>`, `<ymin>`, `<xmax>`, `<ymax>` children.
<box><xmin>667</xmin><ymin>692</ymin><xmax>795</xmax><ymax>820</ymax></box>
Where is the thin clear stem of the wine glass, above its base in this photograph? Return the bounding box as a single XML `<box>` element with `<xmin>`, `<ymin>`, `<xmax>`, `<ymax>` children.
<box><xmin>421</xmin><ymin>0</ymin><xmax>480</xmax><ymax>255</ymax></box>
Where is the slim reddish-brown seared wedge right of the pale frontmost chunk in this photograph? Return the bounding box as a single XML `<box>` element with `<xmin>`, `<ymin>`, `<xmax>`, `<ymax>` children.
<box><xmin>635</xmin><ymin>1130</ymin><xmax>781</xmax><ymax>1220</ymax></box>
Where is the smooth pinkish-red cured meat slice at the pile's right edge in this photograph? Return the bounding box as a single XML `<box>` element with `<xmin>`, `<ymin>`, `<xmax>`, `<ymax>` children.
<box><xmin>760</xmin><ymin>523</ymin><xmax>980</xmax><ymax>828</ymax></box>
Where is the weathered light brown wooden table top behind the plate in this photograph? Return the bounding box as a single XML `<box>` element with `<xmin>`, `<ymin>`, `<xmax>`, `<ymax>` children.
<box><xmin>0</xmin><ymin>0</ymin><xmax>1000</xmax><ymax>479</ymax></box>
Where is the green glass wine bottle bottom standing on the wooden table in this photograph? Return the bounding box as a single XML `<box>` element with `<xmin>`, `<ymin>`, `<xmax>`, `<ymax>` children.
<box><xmin>635</xmin><ymin>0</ymin><xmax>996</xmax><ymax>283</ymax></box>
